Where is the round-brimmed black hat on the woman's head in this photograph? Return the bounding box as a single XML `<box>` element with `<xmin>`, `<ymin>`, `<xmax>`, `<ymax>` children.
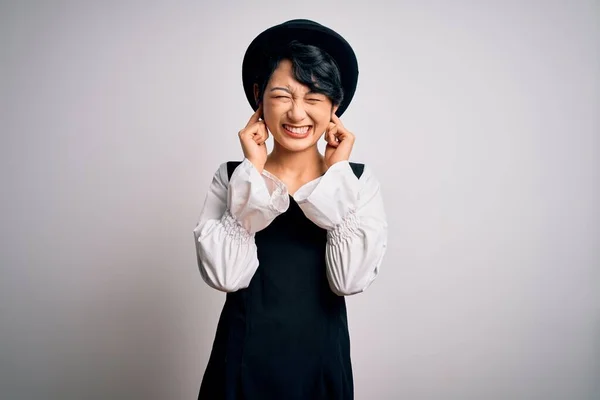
<box><xmin>242</xmin><ymin>19</ymin><xmax>358</xmax><ymax>117</ymax></box>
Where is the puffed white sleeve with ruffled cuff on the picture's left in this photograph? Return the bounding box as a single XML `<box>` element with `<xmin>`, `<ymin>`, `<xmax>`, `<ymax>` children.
<box><xmin>194</xmin><ymin>159</ymin><xmax>289</xmax><ymax>292</ymax></box>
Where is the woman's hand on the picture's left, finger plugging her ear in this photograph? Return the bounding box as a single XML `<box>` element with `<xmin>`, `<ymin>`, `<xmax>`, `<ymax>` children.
<box><xmin>238</xmin><ymin>103</ymin><xmax>269</xmax><ymax>173</ymax></box>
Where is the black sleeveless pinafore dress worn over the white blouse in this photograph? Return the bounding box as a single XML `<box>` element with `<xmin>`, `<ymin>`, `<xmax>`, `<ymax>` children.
<box><xmin>198</xmin><ymin>162</ymin><xmax>364</xmax><ymax>400</ymax></box>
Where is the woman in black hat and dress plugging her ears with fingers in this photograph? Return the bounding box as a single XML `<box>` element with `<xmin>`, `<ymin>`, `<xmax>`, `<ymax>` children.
<box><xmin>194</xmin><ymin>20</ymin><xmax>387</xmax><ymax>400</ymax></box>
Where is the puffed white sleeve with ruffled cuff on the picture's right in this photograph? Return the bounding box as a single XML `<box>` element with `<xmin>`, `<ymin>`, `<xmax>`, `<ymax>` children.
<box><xmin>294</xmin><ymin>161</ymin><xmax>388</xmax><ymax>296</ymax></box>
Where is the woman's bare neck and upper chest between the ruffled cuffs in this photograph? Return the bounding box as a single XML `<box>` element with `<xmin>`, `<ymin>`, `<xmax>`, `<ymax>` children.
<box><xmin>265</xmin><ymin>142</ymin><xmax>325</xmax><ymax>178</ymax></box>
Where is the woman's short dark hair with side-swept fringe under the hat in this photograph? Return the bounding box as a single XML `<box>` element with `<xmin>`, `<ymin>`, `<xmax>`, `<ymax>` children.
<box><xmin>256</xmin><ymin>40</ymin><xmax>344</xmax><ymax>106</ymax></box>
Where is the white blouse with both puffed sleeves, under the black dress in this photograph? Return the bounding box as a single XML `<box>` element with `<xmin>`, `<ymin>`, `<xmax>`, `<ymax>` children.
<box><xmin>194</xmin><ymin>159</ymin><xmax>387</xmax><ymax>296</ymax></box>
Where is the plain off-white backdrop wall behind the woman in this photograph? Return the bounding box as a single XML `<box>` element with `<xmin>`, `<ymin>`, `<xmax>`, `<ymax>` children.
<box><xmin>0</xmin><ymin>0</ymin><xmax>600</xmax><ymax>400</ymax></box>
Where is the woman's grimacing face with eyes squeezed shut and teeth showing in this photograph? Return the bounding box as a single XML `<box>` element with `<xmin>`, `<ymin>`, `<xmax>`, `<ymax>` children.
<box><xmin>254</xmin><ymin>60</ymin><xmax>337</xmax><ymax>151</ymax></box>
